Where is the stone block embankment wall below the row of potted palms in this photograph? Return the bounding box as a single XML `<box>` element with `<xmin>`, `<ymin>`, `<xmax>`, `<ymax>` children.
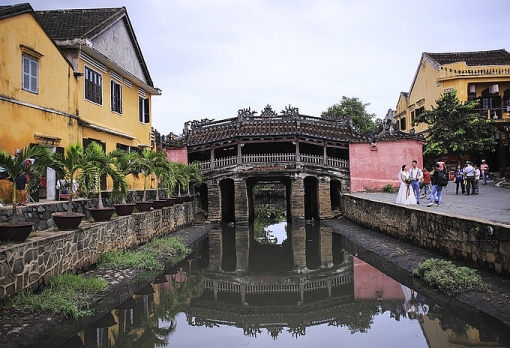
<box><xmin>0</xmin><ymin>203</ymin><xmax>195</xmax><ymax>298</ymax></box>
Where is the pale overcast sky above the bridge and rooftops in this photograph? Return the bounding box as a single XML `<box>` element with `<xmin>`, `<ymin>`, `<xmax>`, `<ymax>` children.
<box><xmin>4</xmin><ymin>0</ymin><xmax>510</xmax><ymax>135</ymax></box>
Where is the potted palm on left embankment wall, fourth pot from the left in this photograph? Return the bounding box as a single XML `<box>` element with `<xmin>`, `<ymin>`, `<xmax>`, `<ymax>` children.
<box><xmin>111</xmin><ymin>150</ymin><xmax>140</xmax><ymax>216</ymax></box>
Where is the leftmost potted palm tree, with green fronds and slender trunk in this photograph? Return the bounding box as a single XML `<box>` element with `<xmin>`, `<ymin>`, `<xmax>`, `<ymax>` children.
<box><xmin>0</xmin><ymin>145</ymin><xmax>51</xmax><ymax>224</ymax></box>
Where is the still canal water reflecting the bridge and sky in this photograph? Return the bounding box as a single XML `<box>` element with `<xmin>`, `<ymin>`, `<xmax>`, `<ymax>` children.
<box><xmin>59</xmin><ymin>223</ymin><xmax>509</xmax><ymax>348</ymax></box>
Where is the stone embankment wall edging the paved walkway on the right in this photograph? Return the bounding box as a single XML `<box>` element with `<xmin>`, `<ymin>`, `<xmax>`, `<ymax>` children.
<box><xmin>342</xmin><ymin>194</ymin><xmax>510</xmax><ymax>278</ymax></box>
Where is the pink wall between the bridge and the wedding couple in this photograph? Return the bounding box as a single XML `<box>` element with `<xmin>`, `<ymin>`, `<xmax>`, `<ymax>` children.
<box><xmin>349</xmin><ymin>139</ymin><xmax>423</xmax><ymax>192</ymax></box>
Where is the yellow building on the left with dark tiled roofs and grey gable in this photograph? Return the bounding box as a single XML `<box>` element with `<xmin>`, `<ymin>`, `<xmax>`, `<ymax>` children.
<box><xmin>0</xmin><ymin>4</ymin><xmax>161</xmax><ymax>199</ymax></box>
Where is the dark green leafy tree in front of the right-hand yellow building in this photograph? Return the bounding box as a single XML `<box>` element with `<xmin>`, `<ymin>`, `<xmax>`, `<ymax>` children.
<box><xmin>413</xmin><ymin>92</ymin><xmax>496</xmax><ymax>156</ymax></box>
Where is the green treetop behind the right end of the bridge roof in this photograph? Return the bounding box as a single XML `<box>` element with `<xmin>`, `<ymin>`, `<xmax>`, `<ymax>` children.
<box><xmin>321</xmin><ymin>96</ymin><xmax>377</xmax><ymax>133</ymax></box>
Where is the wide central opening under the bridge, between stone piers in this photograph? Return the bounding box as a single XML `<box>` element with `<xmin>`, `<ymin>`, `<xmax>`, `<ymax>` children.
<box><xmin>246</xmin><ymin>177</ymin><xmax>291</xmax><ymax>222</ymax></box>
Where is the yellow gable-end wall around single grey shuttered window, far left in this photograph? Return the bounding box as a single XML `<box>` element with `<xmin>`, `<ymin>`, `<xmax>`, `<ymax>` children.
<box><xmin>0</xmin><ymin>14</ymin><xmax>79</xmax><ymax>152</ymax></box>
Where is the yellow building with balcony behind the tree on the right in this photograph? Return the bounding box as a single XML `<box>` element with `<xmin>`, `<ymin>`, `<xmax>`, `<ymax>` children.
<box><xmin>394</xmin><ymin>49</ymin><xmax>510</xmax><ymax>173</ymax></box>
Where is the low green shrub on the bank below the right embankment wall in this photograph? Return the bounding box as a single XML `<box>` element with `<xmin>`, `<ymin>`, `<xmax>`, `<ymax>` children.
<box><xmin>413</xmin><ymin>258</ymin><xmax>490</xmax><ymax>295</ymax></box>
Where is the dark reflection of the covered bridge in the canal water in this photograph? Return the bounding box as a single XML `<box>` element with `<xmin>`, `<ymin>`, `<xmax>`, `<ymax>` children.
<box><xmin>186</xmin><ymin>226</ymin><xmax>364</xmax><ymax>334</ymax></box>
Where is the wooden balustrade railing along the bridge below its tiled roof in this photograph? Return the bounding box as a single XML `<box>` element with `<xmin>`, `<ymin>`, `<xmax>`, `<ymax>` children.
<box><xmin>200</xmin><ymin>153</ymin><xmax>349</xmax><ymax>171</ymax></box>
